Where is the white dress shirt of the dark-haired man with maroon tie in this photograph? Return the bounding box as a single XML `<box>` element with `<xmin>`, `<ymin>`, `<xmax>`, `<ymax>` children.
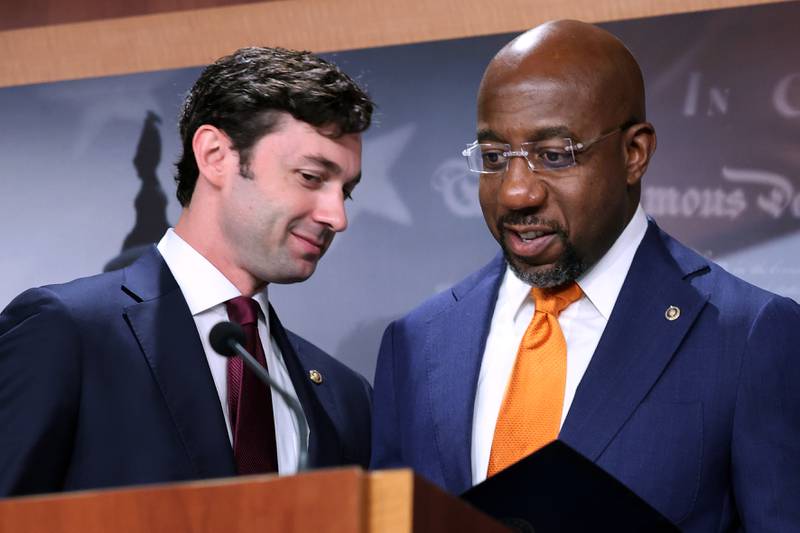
<box><xmin>158</xmin><ymin>228</ymin><xmax>308</xmax><ymax>474</ymax></box>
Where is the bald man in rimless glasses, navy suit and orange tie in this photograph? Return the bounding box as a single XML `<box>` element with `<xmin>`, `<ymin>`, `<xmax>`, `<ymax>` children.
<box><xmin>371</xmin><ymin>21</ymin><xmax>800</xmax><ymax>531</ymax></box>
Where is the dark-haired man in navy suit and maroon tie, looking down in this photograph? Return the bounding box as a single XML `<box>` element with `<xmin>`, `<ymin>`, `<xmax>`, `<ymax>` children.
<box><xmin>0</xmin><ymin>44</ymin><xmax>373</xmax><ymax>496</ymax></box>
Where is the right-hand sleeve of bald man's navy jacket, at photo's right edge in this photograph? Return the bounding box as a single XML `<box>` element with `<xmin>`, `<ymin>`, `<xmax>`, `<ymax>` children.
<box><xmin>732</xmin><ymin>297</ymin><xmax>800</xmax><ymax>531</ymax></box>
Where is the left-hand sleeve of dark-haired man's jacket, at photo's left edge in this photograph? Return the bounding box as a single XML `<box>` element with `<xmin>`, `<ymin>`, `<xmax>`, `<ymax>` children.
<box><xmin>0</xmin><ymin>289</ymin><xmax>80</xmax><ymax>496</ymax></box>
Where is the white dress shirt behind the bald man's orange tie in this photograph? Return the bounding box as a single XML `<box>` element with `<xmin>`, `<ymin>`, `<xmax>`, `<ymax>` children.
<box><xmin>472</xmin><ymin>206</ymin><xmax>647</xmax><ymax>484</ymax></box>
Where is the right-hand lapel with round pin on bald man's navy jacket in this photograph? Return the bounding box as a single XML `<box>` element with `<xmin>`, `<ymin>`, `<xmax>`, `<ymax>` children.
<box><xmin>559</xmin><ymin>223</ymin><xmax>708</xmax><ymax>460</ymax></box>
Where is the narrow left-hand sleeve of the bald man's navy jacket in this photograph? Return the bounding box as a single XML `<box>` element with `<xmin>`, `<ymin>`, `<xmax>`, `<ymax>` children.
<box><xmin>370</xmin><ymin>323</ymin><xmax>405</xmax><ymax>469</ymax></box>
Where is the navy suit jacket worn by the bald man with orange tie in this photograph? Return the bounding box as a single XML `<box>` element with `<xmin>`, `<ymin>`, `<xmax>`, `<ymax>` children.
<box><xmin>372</xmin><ymin>223</ymin><xmax>800</xmax><ymax>532</ymax></box>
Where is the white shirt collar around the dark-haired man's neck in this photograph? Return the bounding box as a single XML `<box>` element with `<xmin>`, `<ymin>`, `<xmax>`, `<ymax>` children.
<box><xmin>158</xmin><ymin>228</ymin><xmax>269</xmax><ymax>317</ymax></box>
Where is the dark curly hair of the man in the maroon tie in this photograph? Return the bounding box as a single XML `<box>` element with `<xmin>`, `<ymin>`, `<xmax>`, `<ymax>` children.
<box><xmin>175</xmin><ymin>47</ymin><xmax>373</xmax><ymax>207</ymax></box>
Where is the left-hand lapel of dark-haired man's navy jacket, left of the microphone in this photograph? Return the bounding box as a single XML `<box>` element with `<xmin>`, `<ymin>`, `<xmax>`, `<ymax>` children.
<box><xmin>122</xmin><ymin>248</ymin><xmax>236</xmax><ymax>477</ymax></box>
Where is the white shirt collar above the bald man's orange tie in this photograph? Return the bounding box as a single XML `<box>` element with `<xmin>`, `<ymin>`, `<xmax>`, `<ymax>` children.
<box><xmin>506</xmin><ymin>205</ymin><xmax>647</xmax><ymax>320</ymax></box>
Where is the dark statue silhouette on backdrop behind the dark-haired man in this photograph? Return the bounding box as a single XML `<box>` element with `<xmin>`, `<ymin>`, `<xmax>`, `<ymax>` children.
<box><xmin>103</xmin><ymin>111</ymin><xmax>169</xmax><ymax>272</ymax></box>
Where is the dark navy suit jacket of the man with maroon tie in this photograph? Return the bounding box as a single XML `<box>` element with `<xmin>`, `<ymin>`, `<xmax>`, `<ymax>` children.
<box><xmin>0</xmin><ymin>248</ymin><xmax>371</xmax><ymax>496</ymax></box>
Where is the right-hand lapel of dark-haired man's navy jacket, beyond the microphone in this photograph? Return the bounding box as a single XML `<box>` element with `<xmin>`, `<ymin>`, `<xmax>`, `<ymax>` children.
<box><xmin>269</xmin><ymin>306</ymin><xmax>343</xmax><ymax>467</ymax></box>
